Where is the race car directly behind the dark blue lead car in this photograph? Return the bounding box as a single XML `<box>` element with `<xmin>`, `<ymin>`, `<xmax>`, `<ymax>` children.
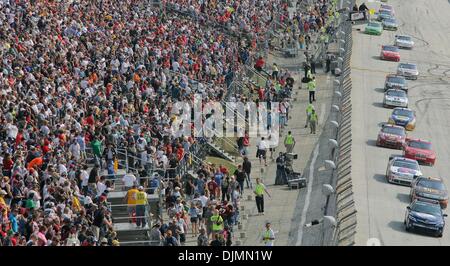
<box><xmin>410</xmin><ymin>176</ymin><xmax>448</xmax><ymax>209</ymax></box>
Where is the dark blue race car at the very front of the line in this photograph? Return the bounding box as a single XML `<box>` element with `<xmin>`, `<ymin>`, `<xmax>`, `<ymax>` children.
<box><xmin>404</xmin><ymin>200</ymin><xmax>447</xmax><ymax>237</ymax></box>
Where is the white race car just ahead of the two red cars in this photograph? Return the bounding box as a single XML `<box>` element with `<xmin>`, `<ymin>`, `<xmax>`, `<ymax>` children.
<box><xmin>386</xmin><ymin>156</ymin><xmax>422</xmax><ymax>186</ymax></box>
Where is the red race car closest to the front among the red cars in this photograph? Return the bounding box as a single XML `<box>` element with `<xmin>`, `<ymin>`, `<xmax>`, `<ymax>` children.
<box><xmin>403</xmin><ymin>138</ymin><xmax>436</xmax><ymax>166</ymax></box>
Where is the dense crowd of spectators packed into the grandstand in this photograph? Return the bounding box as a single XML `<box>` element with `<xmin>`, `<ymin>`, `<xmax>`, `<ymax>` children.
<box><xmin>0</xmin><ymin>0</ymin><xmax>336</xmax><ymax>246</ymax></box>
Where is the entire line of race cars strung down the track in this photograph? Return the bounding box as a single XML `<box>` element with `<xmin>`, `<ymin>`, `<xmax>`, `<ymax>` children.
<box><xmin>364</xmin><ymin>3</ymin><xmax>448</xmax><ymax>237</ymax></box>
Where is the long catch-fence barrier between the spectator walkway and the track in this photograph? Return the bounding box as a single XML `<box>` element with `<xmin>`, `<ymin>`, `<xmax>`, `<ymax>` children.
<box><xmin>325</xmin><ymin>1</ymin><xmax>357</xmax><ymax>246</ymax></box>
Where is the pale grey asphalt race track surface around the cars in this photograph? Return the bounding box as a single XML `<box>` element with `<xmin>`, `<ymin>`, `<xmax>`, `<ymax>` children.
<box><xmin>351</xmin><ymin>0</ymin><xmax>450</xmax><ymax>245</ymax></box>
